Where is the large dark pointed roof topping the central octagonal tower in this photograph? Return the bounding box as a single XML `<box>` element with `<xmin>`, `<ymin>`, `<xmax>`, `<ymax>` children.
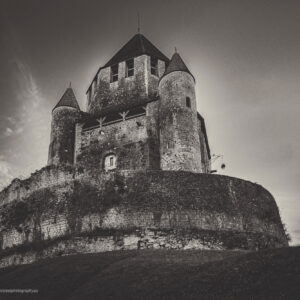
<box><xmin>104</xmin><ymin>33</ymin><xmax>169</xmax><ymax>67</ymax></box>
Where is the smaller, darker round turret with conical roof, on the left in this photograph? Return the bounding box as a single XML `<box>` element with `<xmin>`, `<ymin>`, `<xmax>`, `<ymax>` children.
<box><xmin>48</xmin><ymin>87</ymin><xmax>80</xmax><ymax>165</ymax></box>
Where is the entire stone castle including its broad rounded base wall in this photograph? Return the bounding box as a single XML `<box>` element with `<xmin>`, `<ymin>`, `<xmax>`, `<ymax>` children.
<box><xmin>0</xmin><ymin>34</ymin><xmax>288</xmax><ymax>267</ymax></box>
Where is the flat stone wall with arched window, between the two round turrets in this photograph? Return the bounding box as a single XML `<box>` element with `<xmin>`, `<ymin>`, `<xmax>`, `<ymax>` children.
<box><xmin>75</xmin><ymin>101</ymin><xmax>159</xmax><ymax>170</ymax></box>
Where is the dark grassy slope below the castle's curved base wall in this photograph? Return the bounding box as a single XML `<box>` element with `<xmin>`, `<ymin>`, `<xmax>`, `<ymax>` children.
<box><xmin>0</xmin><ymin>247</ymin><xmax>300</xmax><ymax>300</ymax></box>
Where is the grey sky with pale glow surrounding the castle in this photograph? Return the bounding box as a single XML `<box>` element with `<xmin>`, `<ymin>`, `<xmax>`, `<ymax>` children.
<box><xmin>0</xmin><ymin>0</ymin><xmax>300</xmax><ymax>245</ymax></box>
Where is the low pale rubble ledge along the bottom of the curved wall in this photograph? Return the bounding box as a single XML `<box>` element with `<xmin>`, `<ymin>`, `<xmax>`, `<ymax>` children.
<box><xmin>0</xmin><ymin>229</ymin><xmax>282</xmax><ymax>268</ymax></box>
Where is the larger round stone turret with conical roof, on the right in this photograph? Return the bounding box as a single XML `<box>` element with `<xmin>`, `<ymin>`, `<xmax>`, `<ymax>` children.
<box><xmin>159</xmin><ymin>53</ymin><xmax>202</xmax><ymax>172</ymax></box>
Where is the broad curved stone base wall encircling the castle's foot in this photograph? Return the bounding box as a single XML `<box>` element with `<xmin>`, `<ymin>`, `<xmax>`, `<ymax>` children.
<box><xmin>0</xmin><ymin>167</ymin><xmax>288</xmax><ymax>264</ymax></box>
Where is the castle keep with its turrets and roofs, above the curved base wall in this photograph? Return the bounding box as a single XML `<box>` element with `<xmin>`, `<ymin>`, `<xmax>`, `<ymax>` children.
<box><xmin>48</xmin><ymin>34</ymin><xmax>210</xmax><ymax>173</ymax></box>
